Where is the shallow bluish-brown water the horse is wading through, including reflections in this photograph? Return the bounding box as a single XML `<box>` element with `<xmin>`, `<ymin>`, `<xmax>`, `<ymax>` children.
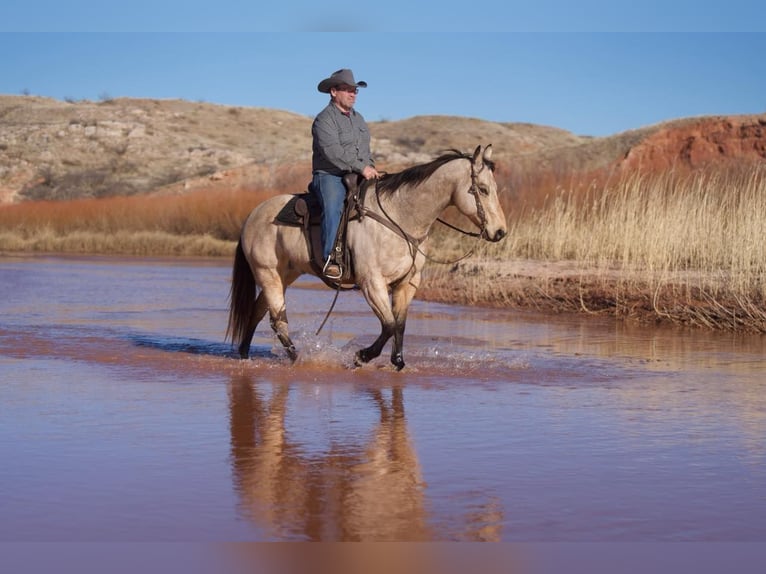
<box><xmin>0</xmin><ymin>257</ymin><xmax>766</xmax><ymax>542</ymax></box>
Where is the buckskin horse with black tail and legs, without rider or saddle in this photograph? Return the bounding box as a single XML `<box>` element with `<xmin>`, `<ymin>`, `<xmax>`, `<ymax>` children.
<box><xmin>226</xmin><ymin>145</ymin><xmax>507</xmax><ymax>370</ymax></box>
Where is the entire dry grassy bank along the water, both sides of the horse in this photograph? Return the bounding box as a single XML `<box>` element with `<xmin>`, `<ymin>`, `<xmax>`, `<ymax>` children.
<box><xmin>0</xmin><ymin>166</ymin><xmax>766</xmax><ymax>332</ymax></box>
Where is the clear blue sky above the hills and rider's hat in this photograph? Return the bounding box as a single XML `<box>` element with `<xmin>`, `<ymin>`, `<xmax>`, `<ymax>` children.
<box><xmin>0</xmin><ymin>4</ymin><xmax>766</xmax><ymax>136</ymax></box>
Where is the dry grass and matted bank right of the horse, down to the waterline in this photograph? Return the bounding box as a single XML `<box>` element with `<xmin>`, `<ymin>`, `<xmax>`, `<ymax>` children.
<box><xmin>422</xmin><ymin>166</ymin><xmax>766</xmax><ymax>332</ymax></box>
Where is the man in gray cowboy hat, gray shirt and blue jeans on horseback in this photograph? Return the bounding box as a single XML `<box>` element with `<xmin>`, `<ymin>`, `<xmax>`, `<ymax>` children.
<box><xmin>311</xmin><ymin>69</ymin><xmax>379</xmax><ymax>279</ymax></box>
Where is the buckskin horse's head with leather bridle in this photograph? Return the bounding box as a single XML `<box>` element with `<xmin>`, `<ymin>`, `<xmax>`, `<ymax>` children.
<box><xmin>453</xmin><ymin>144</ymin><xmax>508</xmax><ymax>241</ymax></box>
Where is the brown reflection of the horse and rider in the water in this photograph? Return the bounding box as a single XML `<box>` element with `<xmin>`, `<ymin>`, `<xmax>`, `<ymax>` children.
<box><xmin>230</xmin><ymin>375</ymin><xmax>499</xmax><ymax>541</ymax></box>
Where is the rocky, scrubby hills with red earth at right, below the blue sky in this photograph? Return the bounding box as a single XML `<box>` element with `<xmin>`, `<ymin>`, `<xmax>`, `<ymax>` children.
<box><xmin>0</xmin><ymin>96</ymin><xmax>766</xmax><ymax>207</ymax></box>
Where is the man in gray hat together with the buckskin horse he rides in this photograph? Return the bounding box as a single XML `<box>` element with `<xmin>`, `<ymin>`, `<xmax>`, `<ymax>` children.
<box><xmin>226</xmin><ymin>69</ymin><xmax>508</xmax><ymax>370</ymax></box>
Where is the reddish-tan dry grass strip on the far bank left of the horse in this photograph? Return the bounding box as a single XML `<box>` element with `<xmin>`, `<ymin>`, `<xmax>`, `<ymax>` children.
<box><xmin>0</xmin><ymin>190</ymin><xmax>273</xmax><ymax>256</ymax></box>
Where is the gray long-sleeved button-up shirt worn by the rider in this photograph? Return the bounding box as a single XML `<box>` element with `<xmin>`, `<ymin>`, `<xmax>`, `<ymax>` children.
<box><xmin>311</xmin><ymin>102</ymin><xmax>375</xmax><ymax>175</ymax></box>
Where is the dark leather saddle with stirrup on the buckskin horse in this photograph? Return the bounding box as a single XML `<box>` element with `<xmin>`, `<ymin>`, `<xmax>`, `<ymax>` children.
<box><xmin>274</xmin><ymin>173</ymin><xmax>370</xmax><ymax>289</ymax></box>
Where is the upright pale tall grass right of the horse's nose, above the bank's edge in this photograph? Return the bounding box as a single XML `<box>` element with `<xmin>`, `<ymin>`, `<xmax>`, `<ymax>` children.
<box><xmin>516</xmin><ymin>168</ymin><xmax>766</xmax><ymax>288</ymax></box>
